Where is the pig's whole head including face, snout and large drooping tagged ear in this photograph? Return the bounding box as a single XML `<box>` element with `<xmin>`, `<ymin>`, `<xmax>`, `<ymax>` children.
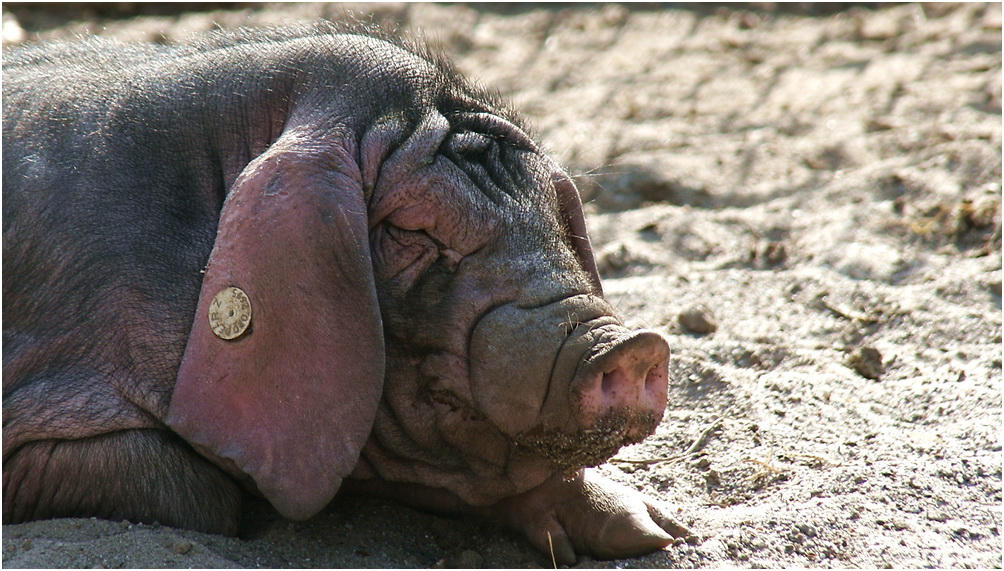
<box><xmin>168</xmin><ymin>33</ymin><xmax>670</xmax><ymax>518</ymax></box>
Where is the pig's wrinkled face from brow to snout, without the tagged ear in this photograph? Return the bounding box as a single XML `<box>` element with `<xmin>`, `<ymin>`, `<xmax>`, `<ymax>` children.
<box><xmin>359</xmin><ymin>110</ymin><xmax>669</xmax><ymax>503</ymax></box>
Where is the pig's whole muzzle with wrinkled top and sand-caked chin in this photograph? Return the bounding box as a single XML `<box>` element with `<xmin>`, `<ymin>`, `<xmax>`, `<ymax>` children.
<box><xmin>471</xmin><ymin>295</ymin><xmax>670</xmax><ymax>469</ymax></box>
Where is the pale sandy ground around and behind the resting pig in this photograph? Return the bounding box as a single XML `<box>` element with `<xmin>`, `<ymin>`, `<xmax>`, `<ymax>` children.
<box><xmin>3</xmin><ymin>4</ymin><xmax>1002</xmax><ymax>568</ymax></box>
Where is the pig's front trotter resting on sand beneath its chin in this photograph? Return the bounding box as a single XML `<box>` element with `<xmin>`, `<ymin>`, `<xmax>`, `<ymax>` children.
<box><xmin>488</xmin><ymin>470</ymin><xmax>690</xmax><ymax>565</ymax></box>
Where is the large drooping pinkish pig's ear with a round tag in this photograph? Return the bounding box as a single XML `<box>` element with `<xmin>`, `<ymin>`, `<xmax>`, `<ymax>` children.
<box><xmin>167</xmin><ymin>135</ymin><xmax>385</xmax><ymax>519</ymax></box>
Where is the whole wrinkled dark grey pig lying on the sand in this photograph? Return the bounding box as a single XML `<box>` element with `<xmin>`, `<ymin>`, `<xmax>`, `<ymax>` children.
<box><xmin>3</xmin><ymin>25</ymin><xmax>686</xmax><ymax>563</ymax></box>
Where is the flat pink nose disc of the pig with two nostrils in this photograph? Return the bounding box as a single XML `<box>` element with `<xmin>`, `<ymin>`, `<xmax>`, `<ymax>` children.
<box><xmin>572</xmin><ymin>330</ymin><xmax>670</xmax><ymax>425</ymax></box>
